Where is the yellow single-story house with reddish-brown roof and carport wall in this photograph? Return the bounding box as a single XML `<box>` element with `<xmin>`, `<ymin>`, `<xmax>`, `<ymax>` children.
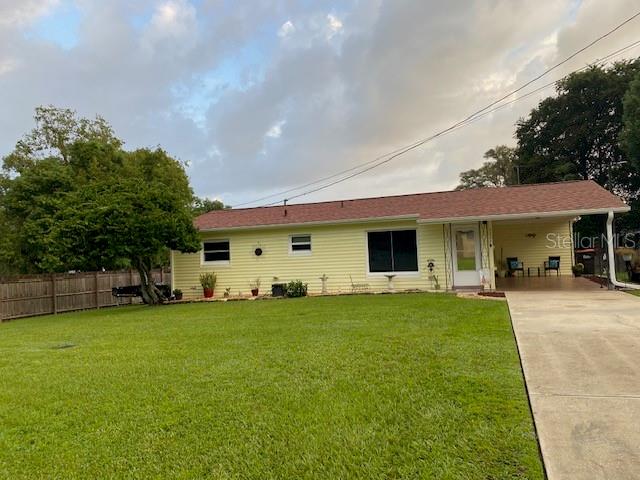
<box><xmin>171</xmin><ymin>181</ymin><xmax>629</xmax><ymax>298</ymax></box>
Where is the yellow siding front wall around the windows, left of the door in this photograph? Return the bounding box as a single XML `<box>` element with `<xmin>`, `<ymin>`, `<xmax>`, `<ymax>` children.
<box><xmin>172</xmin><ymin>221</ymin><xmax>445</xmax><ymax>298</ymax></box>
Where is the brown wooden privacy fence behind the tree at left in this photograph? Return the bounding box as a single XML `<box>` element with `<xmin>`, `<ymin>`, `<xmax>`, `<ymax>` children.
<box><xmin>0</xmin><ymin>270</ymin><xmax>171</xmax><ymax>322</ymax></box>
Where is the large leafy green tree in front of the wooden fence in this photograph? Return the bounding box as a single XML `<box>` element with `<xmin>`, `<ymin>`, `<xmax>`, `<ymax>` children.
<box><xmin>0</xmin><ymin>111</ymin><xmax>199</xmax><ymax>304</ymax></box>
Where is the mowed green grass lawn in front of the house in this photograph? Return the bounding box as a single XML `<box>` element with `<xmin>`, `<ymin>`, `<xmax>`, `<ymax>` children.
<box><xmin>0</xmin><ymin>294</ymin><xmax>542</xmax><ymax>479</ymax></box>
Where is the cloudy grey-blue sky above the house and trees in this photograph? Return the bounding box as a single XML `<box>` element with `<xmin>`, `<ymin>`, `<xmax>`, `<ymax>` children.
<box><xmin>0</xmin><ymin>0</ymin><xmax>640</xmax><ymax>205</ymax></box>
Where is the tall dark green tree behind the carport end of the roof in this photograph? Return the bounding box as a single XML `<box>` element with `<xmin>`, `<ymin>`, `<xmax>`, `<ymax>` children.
<box><xmin>516</xmin><ymin>59</ymin><xmax>640</xmax><ymax>200</ymax></box>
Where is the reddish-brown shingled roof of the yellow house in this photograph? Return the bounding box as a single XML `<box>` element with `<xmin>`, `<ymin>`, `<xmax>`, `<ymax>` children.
<box><xmin>195</xmin><ymin>180</ymin><xmax>628</xmax><ymax>230</ymax></box>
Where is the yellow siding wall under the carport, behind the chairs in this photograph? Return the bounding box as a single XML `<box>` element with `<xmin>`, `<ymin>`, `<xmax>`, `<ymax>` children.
<box><xmin>493</xmin><ymin>218</ymin><xmax>573</xmax><ymax>275</ymax></box>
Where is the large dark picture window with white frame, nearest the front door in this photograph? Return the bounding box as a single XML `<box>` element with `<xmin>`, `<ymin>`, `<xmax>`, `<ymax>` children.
<box><xmin>367</xmin><ymin>230</ymin><xmax>418</xmax><ymax>273</ymax></box>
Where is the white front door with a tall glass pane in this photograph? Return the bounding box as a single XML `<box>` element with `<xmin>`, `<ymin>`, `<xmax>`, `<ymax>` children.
<box><xmin>451</xmin><ymin>224</ymin><xmax>481</xmax><ymax>287</ymax></box>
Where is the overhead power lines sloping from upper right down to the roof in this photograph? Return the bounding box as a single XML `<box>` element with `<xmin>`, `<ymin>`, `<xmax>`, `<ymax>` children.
<box><xmin>235</xmin><ymin>12</ymin><xmax>640</xmax><ymax>208</ymax></box>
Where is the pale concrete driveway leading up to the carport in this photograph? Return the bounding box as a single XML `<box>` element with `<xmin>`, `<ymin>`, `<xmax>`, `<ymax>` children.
<box><xmin>507</xmin><ymin>289</ymin><xmax>640</xmax><ymax>480</ymax></box>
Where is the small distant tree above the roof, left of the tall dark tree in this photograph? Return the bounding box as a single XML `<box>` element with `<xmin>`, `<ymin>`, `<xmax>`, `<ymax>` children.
<box><xmin>457</xmin><ymin>145</ymin><xmax>518</xmax><ymax>190</ymax></box>
